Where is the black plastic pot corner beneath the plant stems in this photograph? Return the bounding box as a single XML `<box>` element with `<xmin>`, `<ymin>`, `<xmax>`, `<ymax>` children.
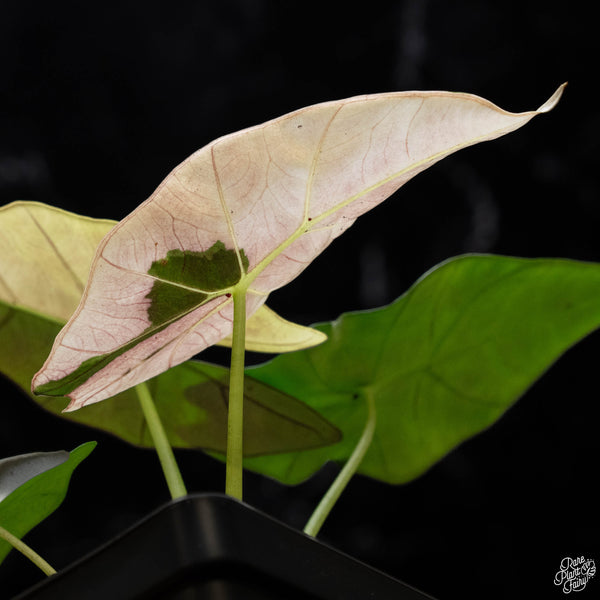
<box><xmin>14</xmin><ymin>494</ymin><xmax>432</xmax><ymax>600</ymax></box>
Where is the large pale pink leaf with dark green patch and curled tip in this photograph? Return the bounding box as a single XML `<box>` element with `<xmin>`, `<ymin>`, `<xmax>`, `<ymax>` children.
<box><xmin>33</xmin><ymin>87</ymin><xmax>562</xmax><ymax>410</ymax></box>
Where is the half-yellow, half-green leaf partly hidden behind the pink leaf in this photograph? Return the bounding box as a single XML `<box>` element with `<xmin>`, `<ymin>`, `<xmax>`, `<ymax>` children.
<box><xmin>0</xmin><ymin>202</ymin><xmax>339</xmax><ymax>455</ymax></box>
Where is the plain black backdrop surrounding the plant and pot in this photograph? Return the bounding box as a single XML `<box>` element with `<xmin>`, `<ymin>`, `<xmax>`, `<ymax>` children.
<box><xmin>0</xmin><ymin>0</ymin><xmax>600</xmax><ymax>600</ymax></box>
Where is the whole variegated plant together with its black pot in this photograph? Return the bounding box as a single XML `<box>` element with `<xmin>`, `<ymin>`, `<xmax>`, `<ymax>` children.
<box><xmin>0</xmin><ymin>86</ymin><xmax>600</xmax><ymax>599</ymax></box>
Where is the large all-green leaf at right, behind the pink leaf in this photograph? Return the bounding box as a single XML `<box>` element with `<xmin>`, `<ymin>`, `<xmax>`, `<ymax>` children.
<box><xmin>245</xmin><ymin>256</ymin><xmax>600</xmax><ymax>484</ymax></box>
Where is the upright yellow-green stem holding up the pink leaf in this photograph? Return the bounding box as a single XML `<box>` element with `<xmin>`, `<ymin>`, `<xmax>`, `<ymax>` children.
<box><xmin>225</xmin><ymin>286</ymin><xmax>246</xmax><ymax>500</ymax></box>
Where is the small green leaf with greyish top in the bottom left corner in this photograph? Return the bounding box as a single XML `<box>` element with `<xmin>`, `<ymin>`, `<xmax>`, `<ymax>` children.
<box><xmin>0</xmin><ymin>442</ymin><xmax>96</xmax><ymax>562</ymax></box>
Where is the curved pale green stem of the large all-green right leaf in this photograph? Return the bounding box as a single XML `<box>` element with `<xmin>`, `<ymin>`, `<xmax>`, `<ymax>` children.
<box><xmin>304</xmin><ymin>389</ymin><xmax>377</xmax><ymax>537</ymax></box>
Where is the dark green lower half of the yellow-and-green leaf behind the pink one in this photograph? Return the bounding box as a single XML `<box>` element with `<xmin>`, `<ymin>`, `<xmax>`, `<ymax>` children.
<box><xmin>0</xmin><ymin>301</ymin><xmax>340</xmax><ymax>456</ymax></box>
